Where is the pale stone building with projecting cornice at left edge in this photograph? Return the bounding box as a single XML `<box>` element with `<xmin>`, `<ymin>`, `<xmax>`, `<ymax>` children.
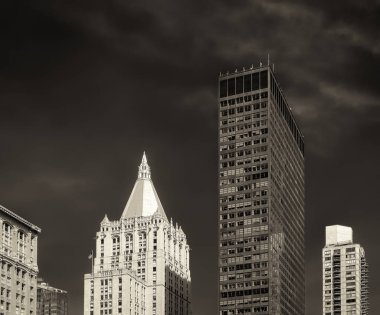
<box><xmin>0</xmin><ymin>206</ymin><xmax>41</xmax><ymax>315</ymax></box>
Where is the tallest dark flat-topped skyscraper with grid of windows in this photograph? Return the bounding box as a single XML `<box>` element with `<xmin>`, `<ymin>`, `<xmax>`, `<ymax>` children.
<box><xmin>219</xmin><ymin>66</ymin><xmax>305</xmax><ymax>315</ymax></box>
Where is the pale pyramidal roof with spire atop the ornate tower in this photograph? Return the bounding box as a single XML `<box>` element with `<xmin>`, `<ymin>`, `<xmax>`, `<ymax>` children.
<box><xmin>121</xmin><ymin>152</ymin><xmax>167</xmax><ymax>220</ymax></box>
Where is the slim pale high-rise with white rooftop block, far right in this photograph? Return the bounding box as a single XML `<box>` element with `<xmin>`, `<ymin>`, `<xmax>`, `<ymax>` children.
<box><xmin>322</xmin><ymin>225</ymin><xmax>369</xmax><ymax>315</ymax></box>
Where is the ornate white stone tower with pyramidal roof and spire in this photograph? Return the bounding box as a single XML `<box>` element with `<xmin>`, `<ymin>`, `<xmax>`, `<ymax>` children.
<box><xmin>84</xmin><ymin>153</ymin><xmax>191</xmax><ymax>315</ymax></box>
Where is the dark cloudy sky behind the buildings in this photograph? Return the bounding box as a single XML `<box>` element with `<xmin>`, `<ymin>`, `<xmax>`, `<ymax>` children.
<box><xmin>0</xmin><ymin>0</ymin><xmax>380</xmax><ymax>315</ymax></box>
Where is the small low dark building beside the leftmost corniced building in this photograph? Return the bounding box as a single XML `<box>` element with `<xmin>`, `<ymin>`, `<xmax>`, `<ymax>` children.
<box><xmin>37</xmin><ymin>278</ymin><xmax>68</xmax><ymax>315</ymax></box>
